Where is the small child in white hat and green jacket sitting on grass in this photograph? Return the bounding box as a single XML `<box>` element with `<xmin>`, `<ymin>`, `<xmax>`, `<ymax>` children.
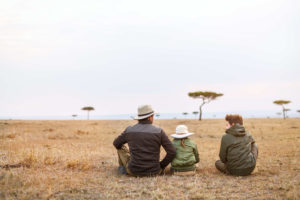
<box><xmin>171</xmin><ymin>125</ymin><xmax>200</xmax><ymax>172</ymax></box>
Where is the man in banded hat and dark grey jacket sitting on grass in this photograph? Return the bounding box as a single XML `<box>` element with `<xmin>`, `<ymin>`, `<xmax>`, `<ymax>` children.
<box><xmin>113</xmin><ymin>105</ymin><xmax>176</xmax><ymax>176</ymax></box>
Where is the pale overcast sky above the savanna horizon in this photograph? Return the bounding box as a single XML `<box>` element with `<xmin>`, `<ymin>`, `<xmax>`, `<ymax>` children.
<box><xmin>0</xmin><ymin>0</ymin><xmax>300</xmax><ymax>117</ymax></box>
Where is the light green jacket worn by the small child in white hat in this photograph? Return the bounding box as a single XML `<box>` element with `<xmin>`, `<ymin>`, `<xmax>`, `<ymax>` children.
<box><xmin>171</xmin><ymin>138</ymin><xmax>200</xmax><ymax>171</ymax></box>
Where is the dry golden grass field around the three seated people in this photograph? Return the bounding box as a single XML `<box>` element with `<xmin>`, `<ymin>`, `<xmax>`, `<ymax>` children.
<box><xmin>0</xmin><ymin>119</ymin><xmax>300</xmax><ymax>199</ymax></box>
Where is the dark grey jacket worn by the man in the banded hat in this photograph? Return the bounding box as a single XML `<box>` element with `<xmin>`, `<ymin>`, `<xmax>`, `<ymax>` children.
<box><xmin>113</xmin><ymin>121</ymin><xmax>176</xmax><ymax>175</ymax></box>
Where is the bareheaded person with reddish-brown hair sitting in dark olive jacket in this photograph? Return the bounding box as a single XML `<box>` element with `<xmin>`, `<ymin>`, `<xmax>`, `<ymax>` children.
<box><xmin>215</xmin><ymin>115</ymin><xmax>258</xmax><ymax>176</ymax></box>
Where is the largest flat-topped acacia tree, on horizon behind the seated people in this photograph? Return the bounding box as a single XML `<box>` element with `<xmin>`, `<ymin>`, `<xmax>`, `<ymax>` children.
<box><xmin>188</xmin><ymin>91</ymin><xmax>223</xmax><ymax>120</ymax></box>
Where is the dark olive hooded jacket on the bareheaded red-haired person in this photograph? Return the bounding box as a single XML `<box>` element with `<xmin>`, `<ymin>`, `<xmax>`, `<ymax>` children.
<box><xmin>219</xmin><ymin>124</ymin><xmax>256</xmax><ymax>175</ymax></box>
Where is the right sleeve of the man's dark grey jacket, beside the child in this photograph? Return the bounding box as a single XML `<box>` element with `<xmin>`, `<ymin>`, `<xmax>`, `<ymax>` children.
<box><xmin>160</xmin><ymin>130</ymin><xmax>176</xmax><ymax>169</ymax></box>
